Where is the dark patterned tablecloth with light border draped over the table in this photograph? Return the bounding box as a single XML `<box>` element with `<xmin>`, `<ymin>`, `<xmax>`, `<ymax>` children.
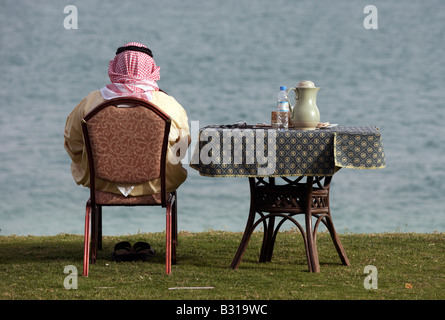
<box><xmin>190</xmin><ymin>126</ymin><xmax>385</xmax><ymax>177</ymax></box>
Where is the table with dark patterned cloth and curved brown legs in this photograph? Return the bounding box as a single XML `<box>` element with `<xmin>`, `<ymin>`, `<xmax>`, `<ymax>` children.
<box><xmin>190</xmin><ymin>125</ymin><xmax>386</xmax><ymax>272</ymax></box>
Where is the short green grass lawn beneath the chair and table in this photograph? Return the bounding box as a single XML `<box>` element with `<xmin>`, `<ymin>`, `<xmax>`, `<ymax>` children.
<box><xmin>0</xmin><ymin>231</ymin><xmax>445</xmax><ymax>300</ymax></box>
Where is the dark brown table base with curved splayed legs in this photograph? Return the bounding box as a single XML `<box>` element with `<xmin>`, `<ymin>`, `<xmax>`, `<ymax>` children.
<box><xmin>231</xmin><ymin>176</ymin><xmax>350</xmax><ymax>272</ymax></box>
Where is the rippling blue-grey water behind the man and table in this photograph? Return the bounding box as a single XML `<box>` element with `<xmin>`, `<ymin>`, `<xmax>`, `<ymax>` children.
<box><xmin>0</xmin><ymin>0</ymin><xmax>445</xmax><ymax>235</ymax></box>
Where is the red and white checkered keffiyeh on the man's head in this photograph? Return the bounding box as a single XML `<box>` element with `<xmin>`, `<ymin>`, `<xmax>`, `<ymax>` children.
<box><xmin>100</xmin><ymin>42</ymin><xmax>160</xmax><ymax>101</ymax></box>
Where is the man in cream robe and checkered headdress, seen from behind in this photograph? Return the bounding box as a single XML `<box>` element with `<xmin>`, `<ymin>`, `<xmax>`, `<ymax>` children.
<box><xmin>64</xmin><ymin>42</ymin><xmax>190</xmax><ymax>196</ymax></box>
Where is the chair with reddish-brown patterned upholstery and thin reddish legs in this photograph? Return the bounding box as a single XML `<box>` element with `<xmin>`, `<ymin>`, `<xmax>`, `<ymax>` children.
<box><xmin>82</xmin><ymin>97</ymin><xmax>177</xmax><ymax>276</ymax></box>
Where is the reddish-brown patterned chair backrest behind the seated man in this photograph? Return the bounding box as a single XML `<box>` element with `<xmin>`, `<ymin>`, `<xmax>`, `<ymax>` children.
<box><xmin>82</xmin><ymin>97</ymin><xmax>171</xmax><ymax>203</ymax></box>
